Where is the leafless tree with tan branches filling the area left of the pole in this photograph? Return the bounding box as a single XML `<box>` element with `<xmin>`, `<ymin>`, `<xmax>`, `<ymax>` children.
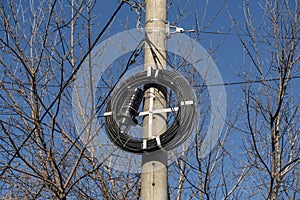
<box><xmin>0</xmin><ymin>0</ymin><xmax>139</xmax><ymax>199</ymax></box>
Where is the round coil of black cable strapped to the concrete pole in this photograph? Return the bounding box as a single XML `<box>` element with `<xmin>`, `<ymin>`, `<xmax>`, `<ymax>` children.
<box><xmin>105</xmin><ymin>69</ymin><xmax>196</xmax><ymax>153</ymax></box>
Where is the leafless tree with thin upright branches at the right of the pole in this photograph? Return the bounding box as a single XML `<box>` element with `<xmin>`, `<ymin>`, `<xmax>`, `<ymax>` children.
<box><xmin>171</xmin><ymin>0</ymin><xmax>300</xmax><ymax>200</ymax></box>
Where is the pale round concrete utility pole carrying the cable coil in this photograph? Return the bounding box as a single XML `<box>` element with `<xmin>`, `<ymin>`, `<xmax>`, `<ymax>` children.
<box><xmin>141</xmin><ymin>0</ymin><xmax>168</xmax><ymax>200</ymax></box>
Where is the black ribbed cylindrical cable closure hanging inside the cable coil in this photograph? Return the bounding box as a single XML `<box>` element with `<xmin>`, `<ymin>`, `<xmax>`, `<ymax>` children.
<box><xmin>117</xmin><ymin>88</ymin><xmax>144</xmax><ymax>127</ymax></box>
